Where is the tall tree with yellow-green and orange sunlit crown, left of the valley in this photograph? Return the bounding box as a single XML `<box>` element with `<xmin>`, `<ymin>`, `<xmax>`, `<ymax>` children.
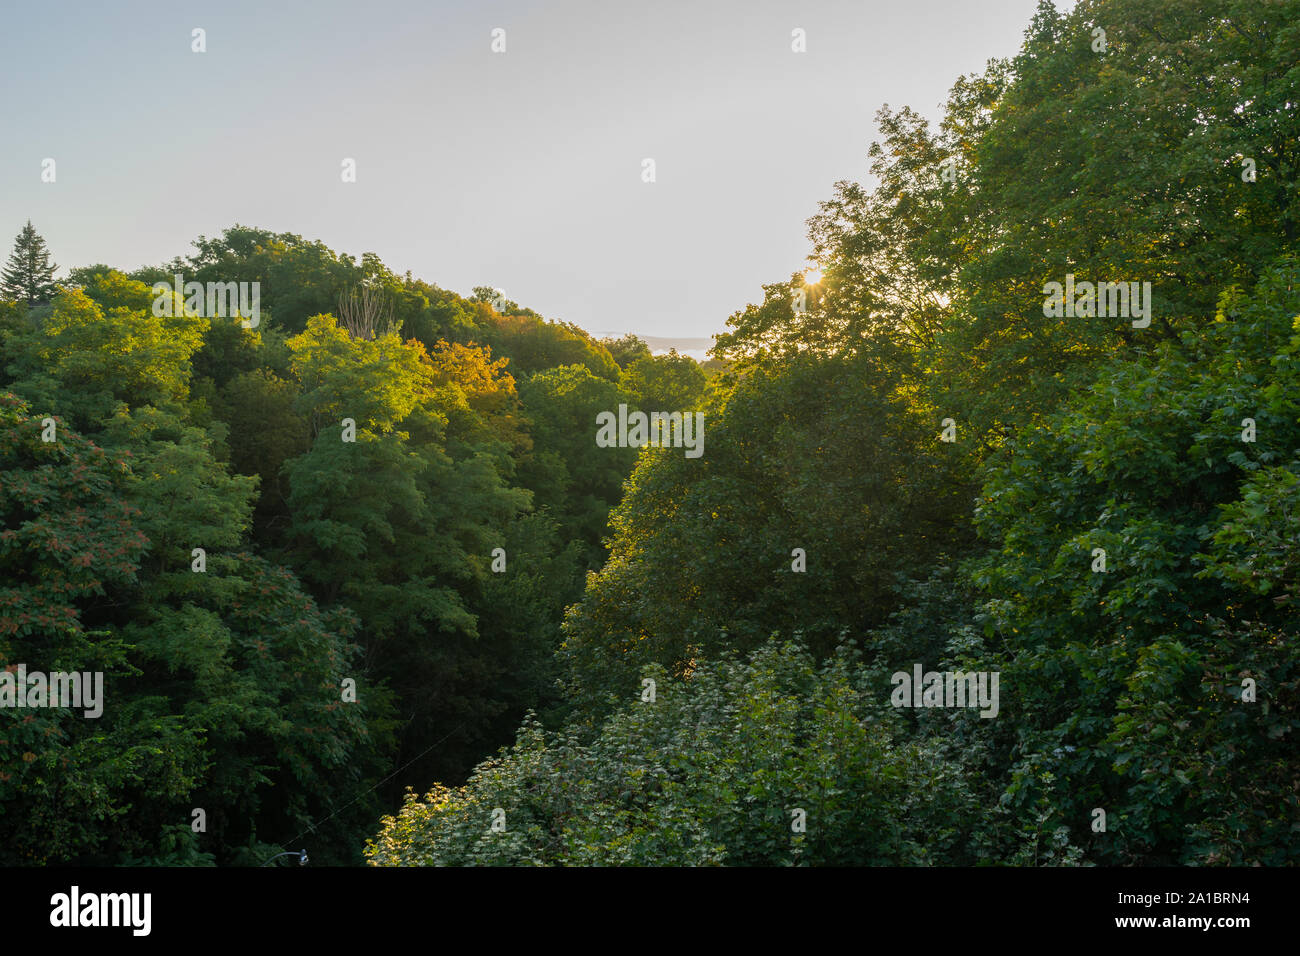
<box><xmin>285</xmin><ymin>316</ymin><xmax>535</xmax><ymax>790</ymax></box>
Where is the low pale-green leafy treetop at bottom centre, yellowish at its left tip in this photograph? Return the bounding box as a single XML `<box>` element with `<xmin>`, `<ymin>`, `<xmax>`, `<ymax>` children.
<box><xmin>367</xmin><ymin>641</ymin><xmax>974</xmax><ymax>866</ymax></box>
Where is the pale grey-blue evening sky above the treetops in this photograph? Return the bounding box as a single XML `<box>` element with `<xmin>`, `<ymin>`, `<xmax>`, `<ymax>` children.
<box><xmin>0</xmin><ymin>0</ymin><xmax>1071</xmax><ymax>337</ymax></box>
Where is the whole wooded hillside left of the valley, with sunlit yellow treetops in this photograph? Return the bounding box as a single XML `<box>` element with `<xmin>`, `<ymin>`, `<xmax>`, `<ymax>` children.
<box><xmin>0</xmin><ymin>218</ymin><xmax>706</xmax><ymax>864</ymax></box>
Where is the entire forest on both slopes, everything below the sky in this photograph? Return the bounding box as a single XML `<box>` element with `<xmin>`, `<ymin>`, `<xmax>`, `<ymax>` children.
<box><xmin>0</xmin><ymin>0</ymin><xmax>1300</xmax><ymax>866</ymax></box>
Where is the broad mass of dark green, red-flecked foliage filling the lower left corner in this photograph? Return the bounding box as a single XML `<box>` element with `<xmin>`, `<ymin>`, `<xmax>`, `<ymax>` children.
<box><xmin>0</xmin><ymin>393</ymin><xmax>390</xmax><ymax>864</ymax></box>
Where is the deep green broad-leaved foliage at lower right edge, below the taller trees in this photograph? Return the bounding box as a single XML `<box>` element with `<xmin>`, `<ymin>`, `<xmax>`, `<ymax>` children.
<box><xmin>971</xmin><ymin>260</ymin><xmax>1300</xmax><ymax>864</ymax></box>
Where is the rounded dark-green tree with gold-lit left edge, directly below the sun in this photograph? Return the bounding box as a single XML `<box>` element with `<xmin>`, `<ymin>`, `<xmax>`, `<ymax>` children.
<box><xmin>564</xmin><ymin>356</ymin><xmax>967</xmax><ymax>708</ymax></box>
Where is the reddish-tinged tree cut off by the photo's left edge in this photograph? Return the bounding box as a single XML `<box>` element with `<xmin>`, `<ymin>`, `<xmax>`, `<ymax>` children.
<box><xmin>0</xmin><ymin>393</ymin><xmax>149</xmax><ymax>865</ymax></box>
